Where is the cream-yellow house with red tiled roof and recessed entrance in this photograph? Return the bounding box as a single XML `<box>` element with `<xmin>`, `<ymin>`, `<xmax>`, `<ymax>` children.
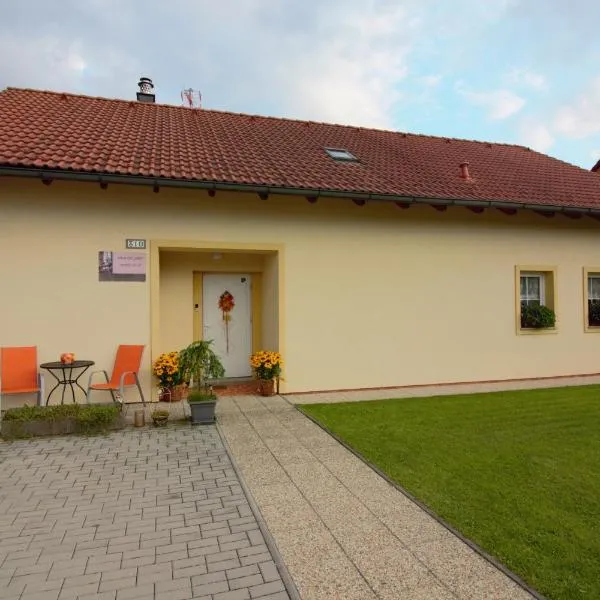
<box><xmin>0</xmin><ymin>78</ymin><xmax>600</xmax><ymax>394</ymax></box>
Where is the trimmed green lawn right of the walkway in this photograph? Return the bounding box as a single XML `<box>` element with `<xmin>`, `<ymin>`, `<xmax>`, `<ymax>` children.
<box><xmin>300</xmin><ymin>386</ymin><xmax>600</xmax><ymax>600</ymax></box>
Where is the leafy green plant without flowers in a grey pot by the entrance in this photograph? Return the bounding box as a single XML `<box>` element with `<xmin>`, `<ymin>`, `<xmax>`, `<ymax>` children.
<box><xmin>179</xmin><ymin>340</ymin><xmax>225</xmax><ymax>424</ymax></box>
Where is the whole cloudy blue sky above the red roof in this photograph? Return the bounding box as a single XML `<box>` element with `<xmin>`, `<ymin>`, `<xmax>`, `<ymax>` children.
<box><xmin>0</xmin><ymin>0</ymin><xmax>600</xmax><ymax>169</ymax></box>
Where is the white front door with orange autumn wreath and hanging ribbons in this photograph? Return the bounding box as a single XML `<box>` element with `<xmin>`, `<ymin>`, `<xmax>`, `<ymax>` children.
<box><xmin>202</xmin><ymin>273</ymin><xmax>252</xmax><ymax>377</ymax></box>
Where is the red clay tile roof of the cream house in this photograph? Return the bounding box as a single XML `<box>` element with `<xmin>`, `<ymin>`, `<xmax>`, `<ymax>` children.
<box><xmin>0</xmin><ymin>88</ymin><xmax>600</xmax><ymax>209</ymax></box>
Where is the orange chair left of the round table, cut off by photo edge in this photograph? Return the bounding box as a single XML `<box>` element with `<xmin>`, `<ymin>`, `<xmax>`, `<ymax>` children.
<box><xmin>0</xmin><ymin>346</ymin><xmax>45</xmax><ymax>409</ymax></box>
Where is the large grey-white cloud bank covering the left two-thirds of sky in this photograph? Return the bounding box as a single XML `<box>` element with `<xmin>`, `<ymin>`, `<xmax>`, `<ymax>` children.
<box><xmin>0</xmin><ymin>0</ymin><xmax>418</xmax><ymax>127</ymax></box>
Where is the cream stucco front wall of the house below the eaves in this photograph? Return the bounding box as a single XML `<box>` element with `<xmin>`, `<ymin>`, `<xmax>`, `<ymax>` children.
<box><xmin>0</xmin><ymin>179</ymin><xmax>600</xmax><ymax>391</ymax></box>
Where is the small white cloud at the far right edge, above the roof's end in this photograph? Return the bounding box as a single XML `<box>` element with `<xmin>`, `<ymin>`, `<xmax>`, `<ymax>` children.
<box><xmin>554</xmin><ymin>77</ymin><xmax>600</xmax><ymax>139</ymax></box>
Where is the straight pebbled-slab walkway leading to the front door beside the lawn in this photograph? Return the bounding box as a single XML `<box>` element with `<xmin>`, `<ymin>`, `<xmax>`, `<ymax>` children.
<box><xmin>218</xmin><ymin>397</ymin><xmax>531</xmax><ymax>600</ymax></box>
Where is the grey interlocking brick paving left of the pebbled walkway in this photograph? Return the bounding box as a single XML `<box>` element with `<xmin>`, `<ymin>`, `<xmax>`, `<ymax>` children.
<box><xmin>0</xmin><ymin>425</ymin><xmax>289</xmax><ymax>600</ymax></box>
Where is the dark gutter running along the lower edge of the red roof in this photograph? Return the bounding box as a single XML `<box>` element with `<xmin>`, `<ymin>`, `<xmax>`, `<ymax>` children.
<box><xmin>0</xmin><ymin>166</ymin><xmax>600</xmax><ymax>216</ymax></box>
